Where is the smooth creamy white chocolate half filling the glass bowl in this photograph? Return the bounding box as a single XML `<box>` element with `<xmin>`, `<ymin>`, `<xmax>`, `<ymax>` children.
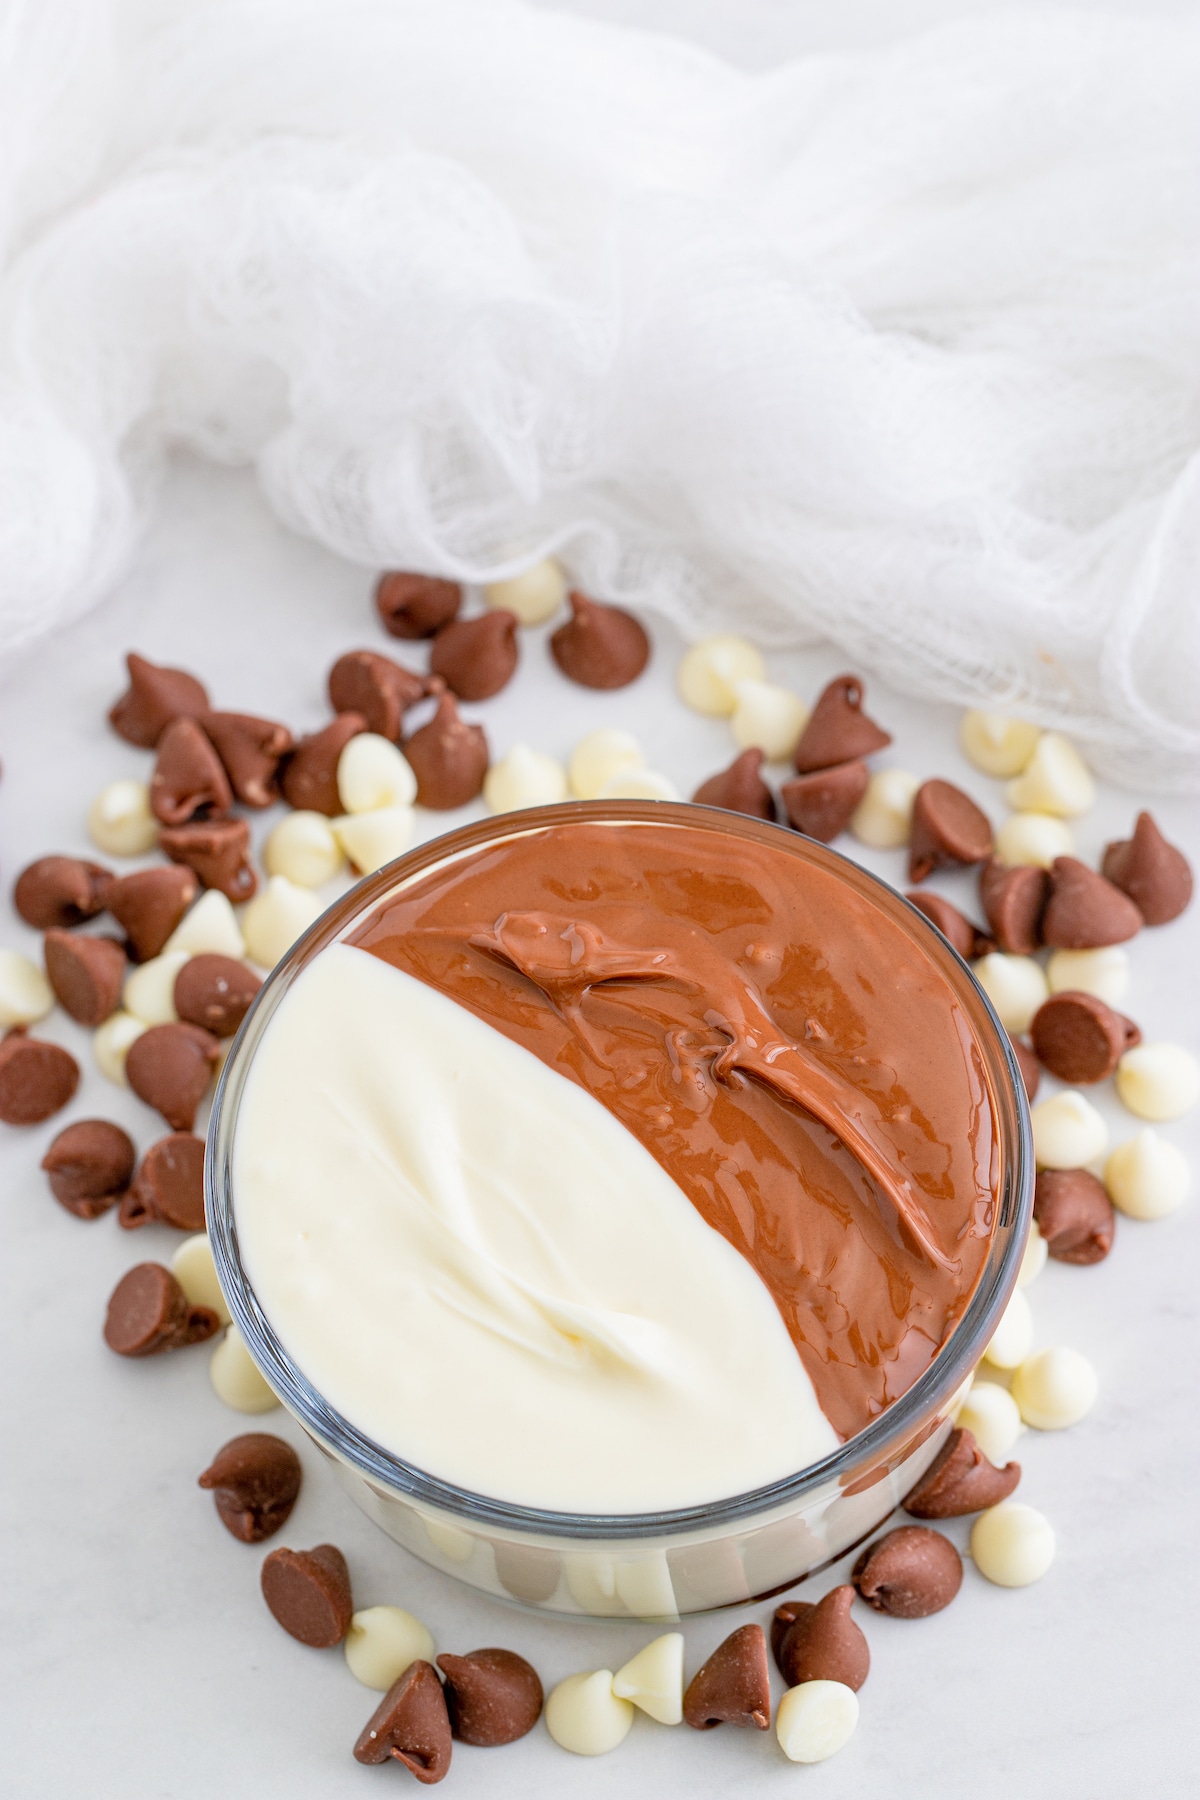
<box><xmin>234</xmin><ymin>945</ymin><xmax>837</xmax><ymax>1512</ymax></box>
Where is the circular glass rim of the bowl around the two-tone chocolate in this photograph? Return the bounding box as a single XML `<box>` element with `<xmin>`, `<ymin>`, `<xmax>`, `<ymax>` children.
<box><xmin>205</xmin><ymin>801</ymin><xmax>1034</xmax><ymax>1541</ymax></box>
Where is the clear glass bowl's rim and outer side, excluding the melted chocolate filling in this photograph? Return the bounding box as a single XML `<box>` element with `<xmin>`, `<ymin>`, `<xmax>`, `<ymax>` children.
<box><xmin>205</xmin><ymin>801</ymin><xmax>1033</xmax><ymax>1620</ymax></box>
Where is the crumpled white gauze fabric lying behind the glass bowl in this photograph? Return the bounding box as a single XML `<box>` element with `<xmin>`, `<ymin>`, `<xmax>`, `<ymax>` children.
<box><xmin>0</xmin><ymin>0</ymin><xmax>1200</xmax><ymax>785</ymax></box>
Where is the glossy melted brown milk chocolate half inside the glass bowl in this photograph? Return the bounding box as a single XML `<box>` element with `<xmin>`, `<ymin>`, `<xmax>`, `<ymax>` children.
<box><xmin>351</xmin><ymin>821</ymin><xmax>999</xmax><ymax>1436</ymax></box>
